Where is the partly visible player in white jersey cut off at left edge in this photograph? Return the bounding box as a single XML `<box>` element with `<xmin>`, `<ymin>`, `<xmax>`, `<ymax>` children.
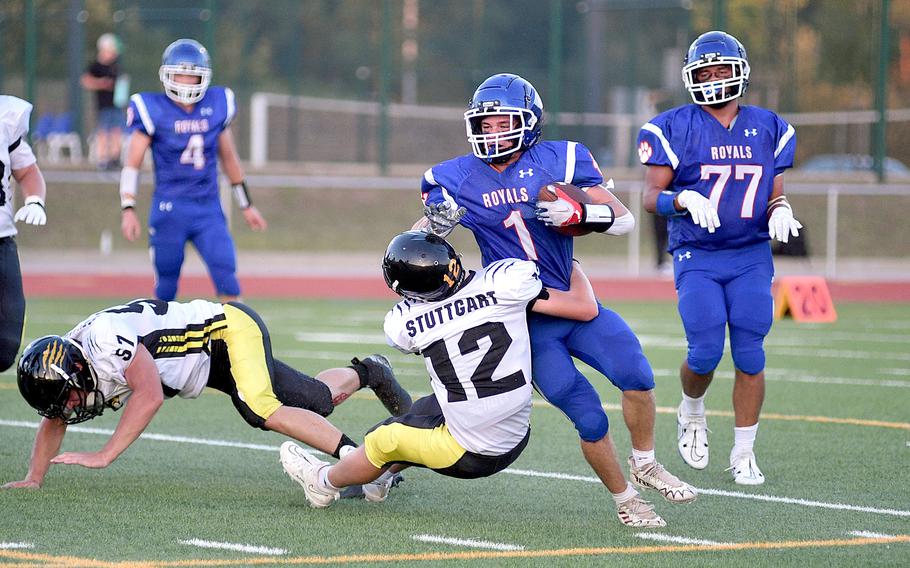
<box><xmin>0</xmin><ymin>95</ymin><xmax>47</xmax><ymax>372</ymax></box>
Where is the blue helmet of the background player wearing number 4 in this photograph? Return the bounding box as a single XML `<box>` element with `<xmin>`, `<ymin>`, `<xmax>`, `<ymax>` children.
<box><xmin>158</xmin><ymin>39</ymin><xmax>212</xmax><ymax>105</ymax></box>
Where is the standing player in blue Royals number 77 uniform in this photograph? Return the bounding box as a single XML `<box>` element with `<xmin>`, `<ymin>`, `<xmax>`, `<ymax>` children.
<box><xmin>638</xmin><ymin>31</ymin><xmax>802</xmax><ymax>485</ymax></box>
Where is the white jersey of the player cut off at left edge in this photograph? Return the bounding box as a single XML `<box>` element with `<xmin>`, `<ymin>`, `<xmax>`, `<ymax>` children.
<box><xmin>0</xmin><ymin>95</ymin><xmax>35</xmax><ymax>238</ymax></box>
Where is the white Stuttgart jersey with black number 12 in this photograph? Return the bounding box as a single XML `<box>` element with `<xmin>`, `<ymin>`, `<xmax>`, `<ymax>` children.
<box><xmin>385</xmin><ymin>259</ymin><xmax>542</xmax><ymax>455</ymax></box>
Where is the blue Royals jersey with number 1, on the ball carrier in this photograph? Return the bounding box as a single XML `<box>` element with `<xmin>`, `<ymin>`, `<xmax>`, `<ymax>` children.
<box><xmin>421</xmin><ymin>140</ymin><xmax>603</xmax><ymax>290</ymax></box>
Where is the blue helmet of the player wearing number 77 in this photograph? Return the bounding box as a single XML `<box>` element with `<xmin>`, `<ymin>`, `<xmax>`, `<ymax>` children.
<box><xmin>682</xmin><ymin>31</ymin><xmax>749</xmax><ymax>105</ymax></box>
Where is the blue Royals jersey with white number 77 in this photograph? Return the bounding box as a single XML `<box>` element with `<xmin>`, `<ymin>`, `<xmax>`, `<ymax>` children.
<box><xmin>638</xmin><ymin>104</ymin><xmax>796</xmax><ymax>251</ymax></box>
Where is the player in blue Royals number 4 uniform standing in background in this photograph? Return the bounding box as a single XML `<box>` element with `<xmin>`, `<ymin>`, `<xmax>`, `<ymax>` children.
<box><xmin>120</xmin><ymin>39</ymin><xmax>266</xmax><ymax>301</ymax></box>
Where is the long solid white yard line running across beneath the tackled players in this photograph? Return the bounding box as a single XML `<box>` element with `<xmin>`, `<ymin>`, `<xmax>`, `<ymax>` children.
<box><xmin>0</xmin><ymin>420</ymin><xmax>910</xmax><ymax>517</ymax></box>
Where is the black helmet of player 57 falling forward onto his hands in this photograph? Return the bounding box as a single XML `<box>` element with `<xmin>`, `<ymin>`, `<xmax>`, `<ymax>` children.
<box><xmin>16</xmin><ymin>335</ymin><xmax>104</xmax><ymax>424</ymax></box>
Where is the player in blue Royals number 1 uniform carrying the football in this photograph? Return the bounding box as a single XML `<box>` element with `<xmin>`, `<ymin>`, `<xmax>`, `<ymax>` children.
<box><xmin>415</xmin><ymin>73</ymin><xmax>696</xmax><ymax>524</ymax></box>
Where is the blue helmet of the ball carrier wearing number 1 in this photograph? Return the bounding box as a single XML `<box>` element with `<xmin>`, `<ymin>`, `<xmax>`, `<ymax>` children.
<box><xmin>464</xmin><ymin>73</ymin><xmax>543</xmax><ymax>164</ymax></box>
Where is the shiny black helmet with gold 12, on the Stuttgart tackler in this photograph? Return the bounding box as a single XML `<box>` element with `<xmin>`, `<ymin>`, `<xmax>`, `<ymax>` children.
<box><xmin>382</xmin><ymin>231</ymin><xmax>464</xmax><ymax>302</ymax></box>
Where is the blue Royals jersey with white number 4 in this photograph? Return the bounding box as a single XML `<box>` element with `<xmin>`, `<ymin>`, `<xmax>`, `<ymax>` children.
<box><xmin>127</xmin><ymin>87</ymin><xmax>236</xmax><ymax>200</ymax></box>
